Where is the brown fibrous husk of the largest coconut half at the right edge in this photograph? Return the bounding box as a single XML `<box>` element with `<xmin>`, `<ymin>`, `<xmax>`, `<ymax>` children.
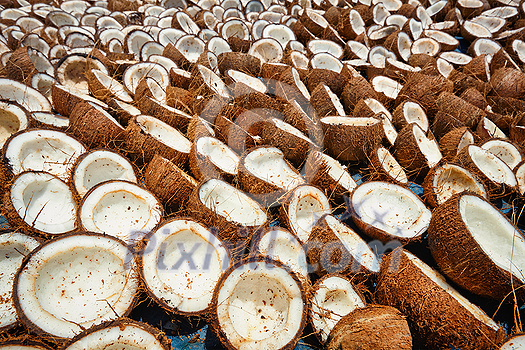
<box><xmin>428</xmin><ymin>192</ymin><xmax>525</xmax><ymax>301</ymax></box>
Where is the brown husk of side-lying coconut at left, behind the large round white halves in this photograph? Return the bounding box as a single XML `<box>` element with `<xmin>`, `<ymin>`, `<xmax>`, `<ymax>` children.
<box><xmin>67</xmin><ymin>102</ymin><xmax>124</xmax><ymax>149</ymax></box>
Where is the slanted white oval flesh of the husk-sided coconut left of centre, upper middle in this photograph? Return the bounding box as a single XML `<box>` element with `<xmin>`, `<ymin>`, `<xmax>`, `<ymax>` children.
<box><xmin>135</xmin><ymin>115</ymin><xmax>191</xmax><ymax>153</ymax></box>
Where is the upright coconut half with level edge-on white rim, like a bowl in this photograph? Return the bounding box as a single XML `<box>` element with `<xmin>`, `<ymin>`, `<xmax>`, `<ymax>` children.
<box><xmin>321</xmin><ymin>117</ymin><xmax>384</xmax><ymax>161</ymax></box>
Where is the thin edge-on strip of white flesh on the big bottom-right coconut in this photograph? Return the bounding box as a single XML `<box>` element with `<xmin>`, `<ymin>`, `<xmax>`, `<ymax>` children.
<box><xmin>403</xmin><ymin>250</ymin><xmax>500</xmax><ymax>330</ymax></box>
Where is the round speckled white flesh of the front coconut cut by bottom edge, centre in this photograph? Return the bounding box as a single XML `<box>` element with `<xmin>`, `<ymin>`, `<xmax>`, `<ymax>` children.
<box><xmin>216</xmin><ymin>262</ymin><xmax>306</xmax><ymax>349</ymax></box>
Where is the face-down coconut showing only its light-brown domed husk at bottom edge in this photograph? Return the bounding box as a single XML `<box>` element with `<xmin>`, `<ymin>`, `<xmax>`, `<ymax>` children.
<box><xmin>327</xmin><ymin>305</ymin><xmax>412</xmax><ymax>350</ymax></box>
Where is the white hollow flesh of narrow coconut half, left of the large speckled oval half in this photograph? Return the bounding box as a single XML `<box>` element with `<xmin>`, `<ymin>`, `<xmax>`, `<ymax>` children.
<box><xmin>288</xmin><ymin>186</ymin><xmax>331</xmax><ymax>242</ymax></box>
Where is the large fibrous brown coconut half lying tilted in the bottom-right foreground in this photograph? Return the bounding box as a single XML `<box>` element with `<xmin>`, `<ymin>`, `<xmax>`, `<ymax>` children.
<box><xmin>376</xmin><ymin>244</ymin><xmax>505</xmax><ymax>350</ymax></box>
